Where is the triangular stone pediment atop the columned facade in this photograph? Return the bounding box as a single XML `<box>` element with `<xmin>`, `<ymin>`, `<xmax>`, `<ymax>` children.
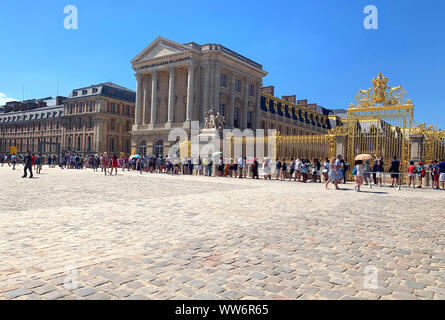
<box><xmin>131</xmin><ymin>37</ymin><xmax>191</xmax><ymax>64</ymax></box>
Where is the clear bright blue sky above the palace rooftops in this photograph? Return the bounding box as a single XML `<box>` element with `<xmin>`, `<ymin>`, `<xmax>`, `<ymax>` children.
<box><xmin>0</xmin><ymin>0</ymin><xmax>445</xmax><ymax>129</ymax></box>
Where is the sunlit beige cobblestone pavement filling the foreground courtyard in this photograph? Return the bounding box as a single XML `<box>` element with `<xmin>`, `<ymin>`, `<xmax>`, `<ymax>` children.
<box><xmin>0</xmin><ymin>167</ymin><xmax>445</xmax><ymax>300</ymax></box>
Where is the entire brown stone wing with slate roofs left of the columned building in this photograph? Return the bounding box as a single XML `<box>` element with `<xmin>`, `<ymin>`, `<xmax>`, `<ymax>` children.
<box><xmin>0</xmin><ymin>82</ymin><xmax>136</xmax><ymax>154</ymax></box>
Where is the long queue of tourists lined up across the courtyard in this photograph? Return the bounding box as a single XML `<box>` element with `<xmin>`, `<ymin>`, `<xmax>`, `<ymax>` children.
<box><xmin>0</xmin><ymin>152</ymin><xmax>445</xmax><ymax>192</ymax></box>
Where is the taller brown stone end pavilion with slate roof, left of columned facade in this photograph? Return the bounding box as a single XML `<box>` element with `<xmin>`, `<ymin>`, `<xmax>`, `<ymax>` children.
<box><xmin>62</xmin><ymin>82</ymin><xmax>136</xmax><ymax>154</ymax></box>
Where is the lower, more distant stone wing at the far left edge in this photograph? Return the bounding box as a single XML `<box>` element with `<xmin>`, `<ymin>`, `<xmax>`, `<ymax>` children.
<box><xmin>0</xmin><ymin>97</ymin><xmax>65</xmax><ymax>153</ymax></box>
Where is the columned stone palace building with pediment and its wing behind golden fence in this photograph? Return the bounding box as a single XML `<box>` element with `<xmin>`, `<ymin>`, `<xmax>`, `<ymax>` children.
<box><xmin>131</xmin><ymin>37</ymin><xmax>338</xmax><ymax>155</ymax></box>
